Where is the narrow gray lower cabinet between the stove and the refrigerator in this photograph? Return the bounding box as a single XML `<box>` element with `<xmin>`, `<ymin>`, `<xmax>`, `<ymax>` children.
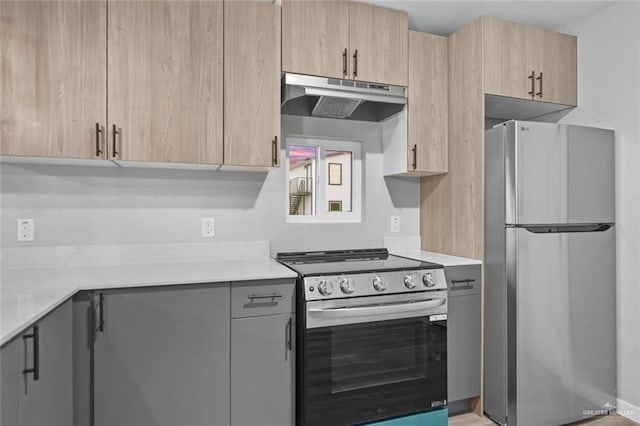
<box><xmin>445</xmin><ymin>265</ymin><xmax>482</xmax><ymax>402</ymax></box>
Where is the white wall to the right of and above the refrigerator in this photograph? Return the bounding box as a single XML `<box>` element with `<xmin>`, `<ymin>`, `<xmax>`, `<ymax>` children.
<box><xmin>560</xmin><ymin>2</ymin><xmax>640</xmax><ymax>421</ymax></box>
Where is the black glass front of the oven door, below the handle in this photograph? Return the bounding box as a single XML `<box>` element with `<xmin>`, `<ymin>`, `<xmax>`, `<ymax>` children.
<box><xmin>304</xmin><ymin>317</ymin><xmax>447</xmax><ymax>425</ymax></box>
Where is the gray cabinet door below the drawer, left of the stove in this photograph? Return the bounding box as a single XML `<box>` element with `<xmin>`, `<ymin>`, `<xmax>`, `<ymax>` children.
<box><xmin>231</xmin><ymin>314</ymin><xmax>295</xmax><ymax>426</ymax></box>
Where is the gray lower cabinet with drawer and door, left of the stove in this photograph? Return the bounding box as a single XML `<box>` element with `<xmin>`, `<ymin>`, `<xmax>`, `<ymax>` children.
<box><xmin>231</xmin><ymin>280</ymin><xmax>295</xmax><ymax>426</ymax></box>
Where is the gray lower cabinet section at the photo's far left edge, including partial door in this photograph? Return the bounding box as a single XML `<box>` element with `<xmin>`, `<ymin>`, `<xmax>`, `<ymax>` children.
<box><xmin>0</xmin><ymin>301</ymin><xmax>73</xmax><ymax>426</ymax></box>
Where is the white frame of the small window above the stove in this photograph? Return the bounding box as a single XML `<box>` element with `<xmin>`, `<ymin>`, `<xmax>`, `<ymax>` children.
<box><xmin>284</xmin><ymin>136</ymin><xmax>363</xmax><ymax>223</ymax></box>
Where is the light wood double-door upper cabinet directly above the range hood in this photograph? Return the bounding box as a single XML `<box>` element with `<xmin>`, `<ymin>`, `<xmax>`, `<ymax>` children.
<box><xmin>282</xmin><ymin>0</ymin><xmax>408</xmax><ymax>86</ymax></box>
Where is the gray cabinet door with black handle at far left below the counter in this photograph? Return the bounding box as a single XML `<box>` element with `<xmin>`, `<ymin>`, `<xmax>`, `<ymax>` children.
<box><xmin>17</xmin><ymin>301</ymin><xmax>73</xmax><ymax>426</ymax></box>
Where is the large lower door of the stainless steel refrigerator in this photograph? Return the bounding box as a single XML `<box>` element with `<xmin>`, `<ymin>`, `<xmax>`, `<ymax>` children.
<box><xmin>506</xmin><ymin>227</ymin><xmax>616</xmax><ymax>426</ymax></box>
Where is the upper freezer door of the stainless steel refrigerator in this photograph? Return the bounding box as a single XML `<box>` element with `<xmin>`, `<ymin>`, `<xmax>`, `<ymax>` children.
<box><xmin>504</xmin><ymin>121</ymin><xmax>615</xmax><ymax>225</ymax></box>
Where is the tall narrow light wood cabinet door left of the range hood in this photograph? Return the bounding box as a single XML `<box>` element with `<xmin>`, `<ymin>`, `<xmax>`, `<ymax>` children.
<box><xmin>224</xmin><ymin>0</ymin><xmax>280</xmax><ymax>167</ymax></box>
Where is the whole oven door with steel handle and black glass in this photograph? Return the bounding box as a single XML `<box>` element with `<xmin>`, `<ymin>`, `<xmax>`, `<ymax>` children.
<box><xmin>302</xmin><ymin>292</ymin><xmax>447</xmax><ymax>426</ymax></box>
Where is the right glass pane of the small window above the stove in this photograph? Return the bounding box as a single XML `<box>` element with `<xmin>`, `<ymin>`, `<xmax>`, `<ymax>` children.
<box><xmin>324</xmin><ymin>150</ymin><xmax>353</xmax><ymax>212</ymax></box>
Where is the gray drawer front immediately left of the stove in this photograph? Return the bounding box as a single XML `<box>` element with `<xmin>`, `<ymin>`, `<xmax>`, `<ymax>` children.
<box><xmin>231</xmin><ymin>280</ymin><xmax>295</xmax><ymax>318</ymax></box>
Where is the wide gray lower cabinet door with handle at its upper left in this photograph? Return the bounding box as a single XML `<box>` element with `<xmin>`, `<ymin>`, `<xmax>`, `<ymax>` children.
<box><xmin>94</xmin><ymin>284</ymin><xmax>230</xmax><ymax>426</ymax></box>
